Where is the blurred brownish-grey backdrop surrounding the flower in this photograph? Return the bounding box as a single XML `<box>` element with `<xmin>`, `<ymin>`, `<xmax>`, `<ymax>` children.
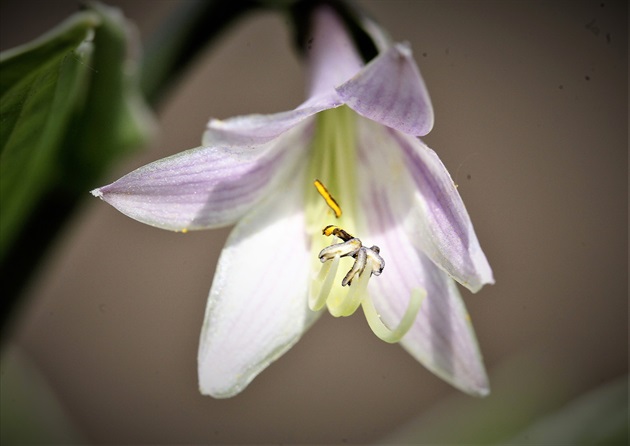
<box><xmin>0</xmin><ymin>0</ymin><xmax>628</xmax><ymax>444</ymax></box>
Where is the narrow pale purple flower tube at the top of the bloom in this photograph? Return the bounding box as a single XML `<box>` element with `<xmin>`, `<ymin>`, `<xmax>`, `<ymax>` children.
<box><xmin>306</xmin><ymin>6</ymin><xmax>363</xmax><ymax>97</ymax></box>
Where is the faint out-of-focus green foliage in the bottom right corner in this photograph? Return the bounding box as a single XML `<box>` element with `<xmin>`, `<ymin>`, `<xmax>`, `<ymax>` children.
<box><xmin>377</xmin><ymin>350</ymin><xmax>628</xmax><ymax>446</ymax></box>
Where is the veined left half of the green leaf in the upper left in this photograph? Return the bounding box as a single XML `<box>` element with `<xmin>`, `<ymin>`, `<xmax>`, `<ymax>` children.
<box><xmin>0</xmin><ymin>12</ymin><xmax>100</xmax><ymax>258</ymax></box>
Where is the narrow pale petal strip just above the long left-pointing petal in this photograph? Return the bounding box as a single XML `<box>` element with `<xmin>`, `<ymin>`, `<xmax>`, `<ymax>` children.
<box><xmin>202</xmin><ymin>94</ymin><xmax>343</xmax><ymax>148</ymax></box>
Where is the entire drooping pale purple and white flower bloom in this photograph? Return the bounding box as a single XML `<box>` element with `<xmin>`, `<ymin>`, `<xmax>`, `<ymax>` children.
<box><xmin>93</xmin><ymin>8</ymin><xmax>493</xmax><ymax>398</ymax></box>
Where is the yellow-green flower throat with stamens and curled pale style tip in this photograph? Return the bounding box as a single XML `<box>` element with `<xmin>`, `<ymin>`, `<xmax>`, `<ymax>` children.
<box><xmin>306</xmin><ymin>106</ymin><xmax>426</xmax><ymax>343</ymax></box>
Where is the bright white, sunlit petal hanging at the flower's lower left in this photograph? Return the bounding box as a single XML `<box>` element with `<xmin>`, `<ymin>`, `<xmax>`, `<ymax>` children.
<box><xmin>198</xmin><ymin>175</ymin><xmax>318</xmax><ymax>398</ymax></box>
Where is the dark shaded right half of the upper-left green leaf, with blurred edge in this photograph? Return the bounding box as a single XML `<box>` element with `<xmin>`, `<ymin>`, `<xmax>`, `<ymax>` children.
<box><xmin>60</xmin><ymin>2</ymin><xmax>153</xmax><ymax>192</ymax></box>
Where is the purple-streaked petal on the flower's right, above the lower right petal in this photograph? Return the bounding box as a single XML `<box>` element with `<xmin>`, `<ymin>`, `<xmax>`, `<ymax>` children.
<box><xmin>357</xmin><ymin>119</ymin><xmax>494</xmax><ymax>292</ymax></box>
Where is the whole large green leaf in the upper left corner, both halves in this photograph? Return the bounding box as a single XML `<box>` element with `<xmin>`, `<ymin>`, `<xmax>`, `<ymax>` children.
<box><xmin>0</xmin><ymin>2</ymin><xmax>153</xmax><ymax>328</ymax></box>
